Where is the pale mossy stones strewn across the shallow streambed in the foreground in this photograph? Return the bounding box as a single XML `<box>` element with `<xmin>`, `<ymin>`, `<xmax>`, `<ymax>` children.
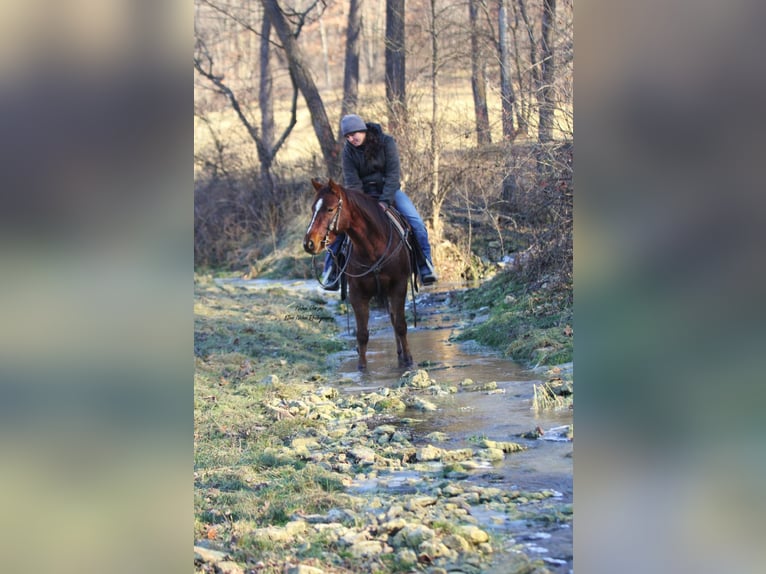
<box><xmin>195</xmin><ymin>370</ymin><xmax>572</xmax><ymax>573</ymax></box>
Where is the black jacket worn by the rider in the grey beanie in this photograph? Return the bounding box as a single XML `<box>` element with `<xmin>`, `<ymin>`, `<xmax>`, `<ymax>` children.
<box><xmin>342</xmin><ymin>123</ymin><xmax>401</xmax><ymax>205</ymax></box>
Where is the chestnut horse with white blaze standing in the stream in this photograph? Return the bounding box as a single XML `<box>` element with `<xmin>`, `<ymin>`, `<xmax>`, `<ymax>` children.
<box><xmin>303</xmin><ymin>178</ymin><xmax>413</xmax><ymax>371</ymax></box>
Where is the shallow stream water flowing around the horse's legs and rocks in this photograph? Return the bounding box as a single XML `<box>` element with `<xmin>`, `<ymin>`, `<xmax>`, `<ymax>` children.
<box><xmin>219</xmin><ymin>280</ymin><xmax>573</xmax><ymax>574</ymax></box>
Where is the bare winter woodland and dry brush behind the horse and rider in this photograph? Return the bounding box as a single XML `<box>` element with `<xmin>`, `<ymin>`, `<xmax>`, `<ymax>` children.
<box><xmin>194</xmin><ymin>0</ymin><xmax>574</xmax><ymax>289</ymax></box>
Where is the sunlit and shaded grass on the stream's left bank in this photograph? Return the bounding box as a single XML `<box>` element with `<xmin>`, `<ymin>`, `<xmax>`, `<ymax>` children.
<box><xmin>194</xmin><ymin>276</ymin><xmax>352</xmax><ymax>545</ymax></box>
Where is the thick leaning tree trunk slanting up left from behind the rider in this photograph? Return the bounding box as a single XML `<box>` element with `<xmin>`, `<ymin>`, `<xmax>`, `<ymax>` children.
<box><xmin>261</xmin><ymin>0</ymin><xmax>341</xmax><ymax>180</ymax></box>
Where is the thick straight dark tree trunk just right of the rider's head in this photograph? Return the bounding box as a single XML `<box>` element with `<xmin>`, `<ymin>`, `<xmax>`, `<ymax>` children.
<box><xmin>386</xmin><ymin>0</ymin><xmax>407</xmax><ymax>134</ymax></box>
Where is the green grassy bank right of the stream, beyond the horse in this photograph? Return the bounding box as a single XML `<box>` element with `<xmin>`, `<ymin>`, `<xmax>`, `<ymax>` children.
<box><xmin>458</xmin><ymin>271</ymin><xmax>574</xmax><ymax>366</ymax></box>
